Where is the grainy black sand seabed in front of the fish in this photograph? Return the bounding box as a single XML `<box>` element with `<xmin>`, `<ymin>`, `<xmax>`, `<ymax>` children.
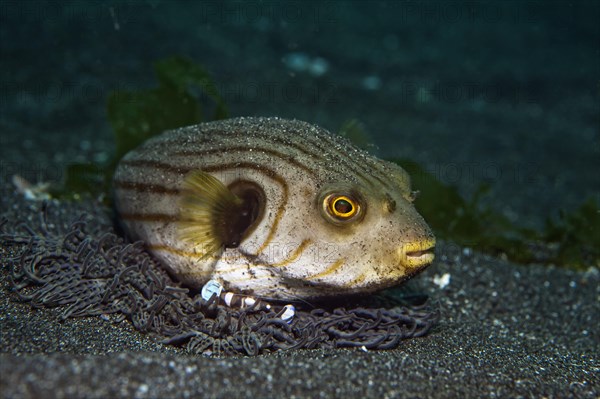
<box><xmin>0</xmin><ymin>187</ymin><xmax>600</xmax><ymax>398</ymax></box>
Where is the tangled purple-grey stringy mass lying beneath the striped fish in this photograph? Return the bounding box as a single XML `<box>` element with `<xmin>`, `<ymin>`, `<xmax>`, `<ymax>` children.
<box><xmin>0</xmin><ymin>203</ymin><xmax>437</xmax><ymax>356</ymax></box>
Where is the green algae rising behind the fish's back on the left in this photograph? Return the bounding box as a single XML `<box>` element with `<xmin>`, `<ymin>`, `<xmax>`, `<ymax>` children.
<box><xmin>51</xmin><ymin>56</ymin><xmax>228</xmax><ymax>201</ymax></box>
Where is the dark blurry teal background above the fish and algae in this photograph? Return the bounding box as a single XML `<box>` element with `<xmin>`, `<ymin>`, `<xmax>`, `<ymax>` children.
<box><xmin>0</xmin><ymin>0</ymin><xmax>600</xmax><ymax>225</ymax></box>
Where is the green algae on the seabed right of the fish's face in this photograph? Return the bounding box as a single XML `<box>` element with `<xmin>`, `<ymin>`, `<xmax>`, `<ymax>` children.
<box><xmin>391</xmin><ymin>159</ymin><xmax>600</xmax><ymax>270</ymax></box>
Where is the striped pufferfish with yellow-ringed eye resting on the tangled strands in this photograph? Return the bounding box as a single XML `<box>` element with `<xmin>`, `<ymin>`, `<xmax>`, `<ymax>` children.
<box><xmin>114</xmin><ymin>118</ymin><xmax>435</xmax><ymax>300</ymax></box>
